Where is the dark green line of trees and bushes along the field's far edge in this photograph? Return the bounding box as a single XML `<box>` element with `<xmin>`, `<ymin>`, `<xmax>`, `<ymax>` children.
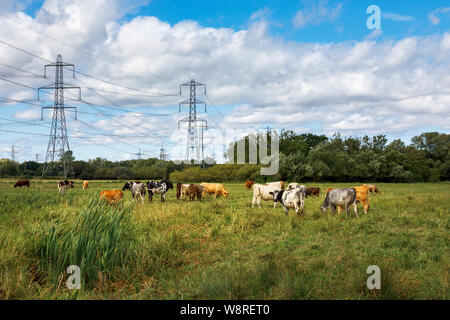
<box><xmin>0</xmin><ymin>130</ymin><xmax>450</xmax><ymax>182</ymax></box>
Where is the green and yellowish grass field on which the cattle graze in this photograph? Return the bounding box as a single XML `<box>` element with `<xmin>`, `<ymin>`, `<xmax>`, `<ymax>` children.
<box><xmin>0</xmin><ymin>179</ymin><xmax>450</xmax><ymax>299</ymax></box>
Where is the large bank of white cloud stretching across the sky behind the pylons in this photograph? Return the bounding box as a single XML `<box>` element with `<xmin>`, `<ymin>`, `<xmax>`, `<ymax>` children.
<box><xmin>0</xmin><ymin>0</ymin><xmax>450</xmax><ymax>160</ymax></box>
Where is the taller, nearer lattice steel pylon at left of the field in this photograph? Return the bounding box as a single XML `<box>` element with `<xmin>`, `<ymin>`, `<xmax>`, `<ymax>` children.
<box><xmin>38</xmin><ymin>54</ymin><xmax>81</xmax><ymax>179</ymax></box>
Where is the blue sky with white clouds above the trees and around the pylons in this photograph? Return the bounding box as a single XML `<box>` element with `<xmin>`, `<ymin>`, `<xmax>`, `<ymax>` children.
<box><xmin>0</xmin><ymin>0</ymin><xmax>450</xmax><ymax>162</ymax></box>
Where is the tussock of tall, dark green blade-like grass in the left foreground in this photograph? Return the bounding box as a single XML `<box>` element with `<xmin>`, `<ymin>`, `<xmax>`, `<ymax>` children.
<box><xmin>31</xmin><ymin>200</ymin><xmax>135</xmax><ymax>287</ymax></box>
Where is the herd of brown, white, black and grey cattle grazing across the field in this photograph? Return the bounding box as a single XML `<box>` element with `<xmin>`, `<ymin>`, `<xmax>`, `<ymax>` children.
<box><xmin>14</xmin><ymin>179</ymin><xmax>380</xmax><ymax>216</ymax></box>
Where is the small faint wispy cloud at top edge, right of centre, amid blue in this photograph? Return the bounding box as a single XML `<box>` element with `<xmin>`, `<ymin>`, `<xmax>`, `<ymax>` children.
<box><xmin>292</xmin><ymin>0</ymin><xmax>342</xmax><ymax>28</ymax></box>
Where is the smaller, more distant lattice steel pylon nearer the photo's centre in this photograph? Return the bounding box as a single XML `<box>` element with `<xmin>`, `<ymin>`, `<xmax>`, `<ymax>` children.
<box><xmin>178</xmin><ymin>79</ymin><xmax>208</xmax><ymax>163</ymax></box>
